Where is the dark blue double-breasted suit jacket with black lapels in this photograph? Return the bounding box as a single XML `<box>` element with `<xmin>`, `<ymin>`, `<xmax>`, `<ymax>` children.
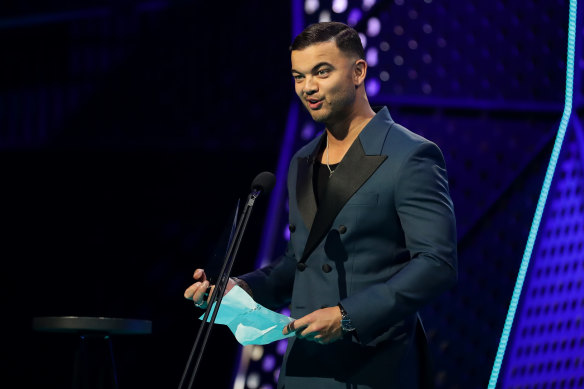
<box><xmin>240</xmin><ymin>107</ymin><xmax>457</xmax><ymax>389</ymax></box>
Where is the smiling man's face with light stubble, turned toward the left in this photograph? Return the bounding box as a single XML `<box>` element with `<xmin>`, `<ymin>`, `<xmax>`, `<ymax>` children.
<box><xmin>292</xmin><ymin>41</ymin><xmax>357</xmax><ymax>124</ymax></box>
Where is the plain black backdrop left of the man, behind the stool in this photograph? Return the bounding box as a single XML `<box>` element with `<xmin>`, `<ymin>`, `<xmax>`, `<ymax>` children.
<box><xmin>0</xmin><ymin>1</ymin><xmax>291</xmax><ymax>388</ymax></box>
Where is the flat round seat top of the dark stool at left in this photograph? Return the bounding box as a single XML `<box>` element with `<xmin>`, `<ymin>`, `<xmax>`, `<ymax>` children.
<box><xmin>33</xmin><ymin>316</ymin><xmax>152</xmax><ymax>335</ymax></box>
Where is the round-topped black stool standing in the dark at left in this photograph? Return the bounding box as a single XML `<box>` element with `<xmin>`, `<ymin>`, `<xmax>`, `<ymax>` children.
<box><xmin>33</xmin><ymin>316</ymin><xmax>152</xmax><ymax>389</ymax></box>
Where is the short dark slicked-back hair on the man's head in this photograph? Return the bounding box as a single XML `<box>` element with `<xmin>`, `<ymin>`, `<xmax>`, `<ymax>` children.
<box><xmin>290</xmin><ymin>22</ymin><xmax>365</xmax><ymax>59</ymax></box>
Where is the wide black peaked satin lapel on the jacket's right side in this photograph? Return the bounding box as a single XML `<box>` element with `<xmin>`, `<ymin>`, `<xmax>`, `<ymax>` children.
<box><xmin>301</xmin><ymin>138</ymin><xmax>387</xmax><ymax>262</ymax></box>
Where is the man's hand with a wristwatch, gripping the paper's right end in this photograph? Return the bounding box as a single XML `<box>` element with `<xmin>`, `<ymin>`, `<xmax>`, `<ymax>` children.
<box><xmin>282</xmin><ymin>307</ymin><xmax>343</xmax><ymax>344</ymax></box>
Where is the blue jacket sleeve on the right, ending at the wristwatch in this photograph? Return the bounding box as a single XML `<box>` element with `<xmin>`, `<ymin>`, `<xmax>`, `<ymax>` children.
<box><xmin>341</xmin><ymin>142</ymin><xmax>458</xmax><ymax>343</ymax></box>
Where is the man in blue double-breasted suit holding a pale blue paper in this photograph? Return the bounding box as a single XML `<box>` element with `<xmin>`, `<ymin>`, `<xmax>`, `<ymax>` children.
<box><xmin>185</xmin><ymin>22</ymin><xmax>457</xmax><ymax>389</ymax></box>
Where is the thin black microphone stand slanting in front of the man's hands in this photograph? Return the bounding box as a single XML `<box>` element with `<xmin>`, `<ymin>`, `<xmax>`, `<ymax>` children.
<box><xmin>178</xmin><ymin>188</ymin><xmax>262</xmax><ymax>389</ymax></box>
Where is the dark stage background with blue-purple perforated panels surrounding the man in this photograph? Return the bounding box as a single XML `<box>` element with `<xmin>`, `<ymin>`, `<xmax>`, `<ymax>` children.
<box><xmin>0</xmin><ymin>0</ymin><xmax>584</xmax><ymax>389</ymax></box>
